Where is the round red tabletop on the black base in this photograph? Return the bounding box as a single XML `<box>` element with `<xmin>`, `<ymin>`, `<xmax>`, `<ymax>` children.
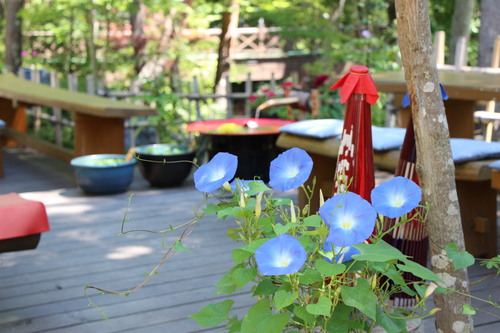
<box><xmin>187</xmin><ymin>118</ymin><xmax>293</xmax><ymax>136</ymax></box>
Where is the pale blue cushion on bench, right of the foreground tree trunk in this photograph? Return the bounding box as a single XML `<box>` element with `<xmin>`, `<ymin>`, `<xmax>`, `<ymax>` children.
<box><xmin>450</xmin><ymin>138</ymin><xmax>500</xmax><ymax>163</ymax></box>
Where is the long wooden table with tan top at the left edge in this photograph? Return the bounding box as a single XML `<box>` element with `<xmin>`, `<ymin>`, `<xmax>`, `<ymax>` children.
<box><xmin>0</xmin><ymin>74</ymin><xmax>156</xmax><ymax>161</ymax></box>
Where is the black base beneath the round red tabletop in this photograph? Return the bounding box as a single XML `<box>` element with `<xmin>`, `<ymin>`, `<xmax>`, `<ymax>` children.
<box><xmin>208</xmin><ymin>134</ymin><xmax>283</xmax><ymax>183</ymax></box>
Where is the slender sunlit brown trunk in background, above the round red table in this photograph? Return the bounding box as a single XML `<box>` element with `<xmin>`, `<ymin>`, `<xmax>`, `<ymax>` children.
<box><xmin>214</xmin><ymin>0</ymin><xmax>240</xmax><ymax>92</ymax></box>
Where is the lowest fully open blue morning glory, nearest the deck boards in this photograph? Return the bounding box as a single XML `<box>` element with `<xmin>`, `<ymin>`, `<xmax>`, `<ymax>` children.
<box><xmin>255</xmin><ymin>234</ymin><xmax>306</xmax><ymax>275</ymax></box>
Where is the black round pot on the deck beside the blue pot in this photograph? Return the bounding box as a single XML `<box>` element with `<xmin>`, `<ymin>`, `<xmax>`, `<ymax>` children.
<box><xmin>135</xmin><ymin>144</ymin><xmax>195</xmax><ymax>187</ymax></box>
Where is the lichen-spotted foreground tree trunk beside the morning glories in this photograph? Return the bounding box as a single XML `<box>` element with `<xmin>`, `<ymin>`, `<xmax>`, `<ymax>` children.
<box><xmin>396</xmin><ymin>0</ymin><xmax>473</xmax><ymax>332</ymax></box>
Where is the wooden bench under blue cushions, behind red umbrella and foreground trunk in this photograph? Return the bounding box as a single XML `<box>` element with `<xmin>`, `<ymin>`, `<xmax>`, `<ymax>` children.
<box><xmin>276</xmin><ymin>122</ymin><xmax>500</xmax><ymax>257</ymax></box>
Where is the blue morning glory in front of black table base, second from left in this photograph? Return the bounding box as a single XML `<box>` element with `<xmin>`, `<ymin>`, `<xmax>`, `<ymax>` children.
<box><xmin>269</xmin><ymin>148</ymin><xmax>313</xmax><ymax>191</ymax></box>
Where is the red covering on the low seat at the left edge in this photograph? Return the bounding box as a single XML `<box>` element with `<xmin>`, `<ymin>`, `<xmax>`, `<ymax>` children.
<box><xmin>0</xmin><ymin>193</ymin><xmax>50</xmax><ymax>239</ymax></box>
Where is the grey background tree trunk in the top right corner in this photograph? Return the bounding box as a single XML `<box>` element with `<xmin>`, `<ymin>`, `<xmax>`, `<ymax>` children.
<box><xmin>478</xmin><ymin>0</ymin><xmax>500</xmax><ymax>67</ymax></box>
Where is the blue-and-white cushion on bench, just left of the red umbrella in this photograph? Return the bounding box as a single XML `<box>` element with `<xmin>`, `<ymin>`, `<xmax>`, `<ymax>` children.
<box><xmin>280</xmin><ymin>119</ymin><xmax>344</xmax><ymax>139</ymax></box>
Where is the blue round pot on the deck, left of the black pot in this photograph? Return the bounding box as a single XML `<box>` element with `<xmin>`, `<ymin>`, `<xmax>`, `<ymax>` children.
<box><xmin>71</xmin><ymin>154</ymin><xmax>136</xmax><ymax>194</ymax></box>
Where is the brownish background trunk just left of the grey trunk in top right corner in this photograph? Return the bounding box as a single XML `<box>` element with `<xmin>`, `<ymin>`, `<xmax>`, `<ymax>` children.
<box><xmin>448</xmin><ymin>0</ymin><xmax>475</xmax><ymax>65</ymax></box>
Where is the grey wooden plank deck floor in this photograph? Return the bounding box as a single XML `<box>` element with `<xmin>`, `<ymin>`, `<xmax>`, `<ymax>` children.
<box><xmin>0</xmin><ymin>150</ymin><xmax>500</xmax><ymax>333</ymax></box>
